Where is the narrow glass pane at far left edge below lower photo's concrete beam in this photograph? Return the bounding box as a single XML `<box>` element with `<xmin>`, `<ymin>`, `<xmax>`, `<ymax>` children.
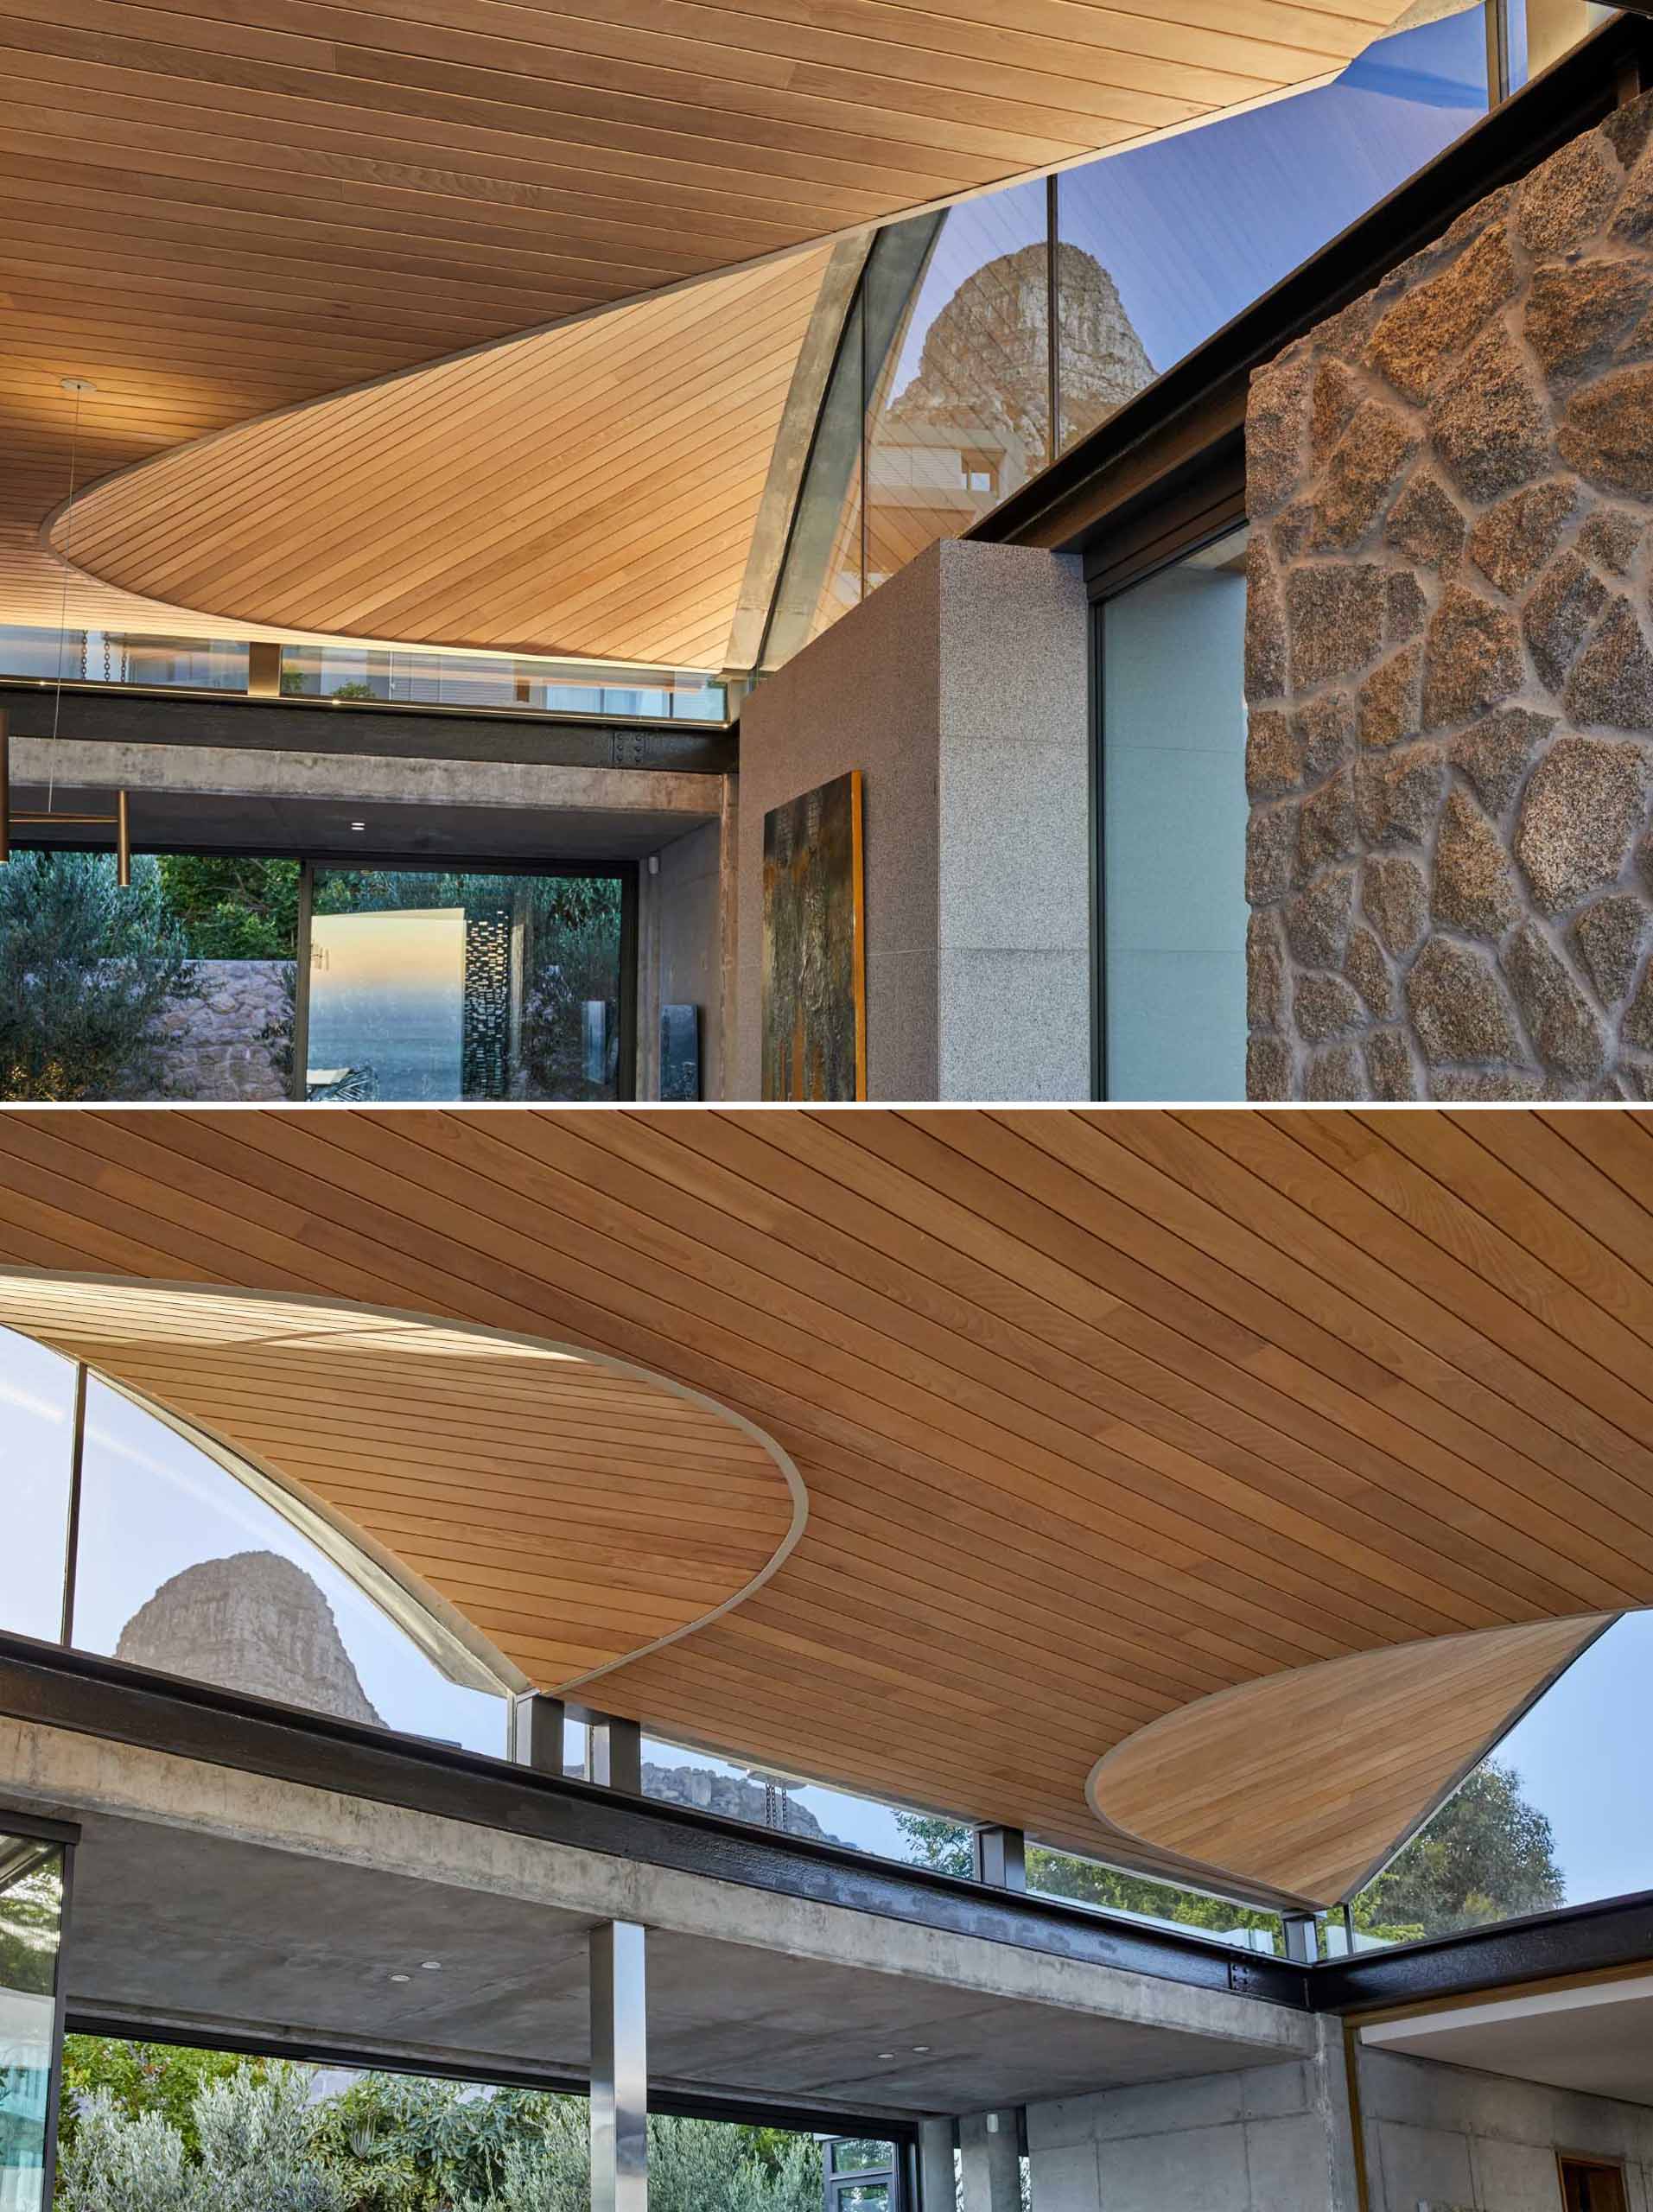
<box><xmin>0</xmin><ymin>1834</ymin><xmax>64</xmax><ymax>2212</ymax></box>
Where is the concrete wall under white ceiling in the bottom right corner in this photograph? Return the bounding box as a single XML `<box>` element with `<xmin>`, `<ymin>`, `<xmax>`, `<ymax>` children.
<box><xmin>1358</xmin><ymin>2050</ymin><xmax>1653</xmax><ymax>2212</ymax></box>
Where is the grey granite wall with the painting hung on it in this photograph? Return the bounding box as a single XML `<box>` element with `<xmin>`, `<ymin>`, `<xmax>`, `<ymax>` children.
<box><xmin>734</xmin><ymin>540</ymin><xmax>1091</xmax><ymax>1099</ymax></box>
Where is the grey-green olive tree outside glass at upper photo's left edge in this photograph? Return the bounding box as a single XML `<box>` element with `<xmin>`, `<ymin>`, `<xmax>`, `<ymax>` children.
<box><xmin>0</xmin><ymin>852</ymin><xmax>193</xmax><ymax>1102</ymax></box>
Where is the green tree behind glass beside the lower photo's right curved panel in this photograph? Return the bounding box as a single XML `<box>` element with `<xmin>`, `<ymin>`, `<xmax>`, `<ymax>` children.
<box><xmin>1354</xmin><ymin>1758</ymin><xmax>1567</xmax><ymax>1942</ymax></box>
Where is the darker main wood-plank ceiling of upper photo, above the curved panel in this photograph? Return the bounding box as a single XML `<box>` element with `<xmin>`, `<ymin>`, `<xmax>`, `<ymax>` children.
<box><xmin>0</xmin><ymin>0</ymin><xmax>1425</xmax><ymax>655</ymax></box>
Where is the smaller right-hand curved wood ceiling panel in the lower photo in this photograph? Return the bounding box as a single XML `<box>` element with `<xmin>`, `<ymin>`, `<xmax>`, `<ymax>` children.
<box><xmin>1089</xmin><ymin>1612</ymin><xmax>1615</xmax><ymax>1904</ymax></box>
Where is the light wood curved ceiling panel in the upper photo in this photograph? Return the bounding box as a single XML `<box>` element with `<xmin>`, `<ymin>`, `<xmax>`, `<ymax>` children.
<box><xmin>53</xmin><ymin>250</ymin><xmax>830</xmax><ymax>668</ymax></box>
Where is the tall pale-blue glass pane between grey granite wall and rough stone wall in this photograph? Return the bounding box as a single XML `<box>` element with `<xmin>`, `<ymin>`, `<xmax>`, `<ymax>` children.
<box><xmin>1100</xmin><ymin>531</ymin><xmax>1246</xmax><ymax>1099</ymax></box>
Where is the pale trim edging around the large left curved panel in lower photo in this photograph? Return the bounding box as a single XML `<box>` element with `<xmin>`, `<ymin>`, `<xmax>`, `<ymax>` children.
<box><xmin>0</xmin><ymin>1265</ymin><xmax>810</xmax><ymax>1697</ymax></box>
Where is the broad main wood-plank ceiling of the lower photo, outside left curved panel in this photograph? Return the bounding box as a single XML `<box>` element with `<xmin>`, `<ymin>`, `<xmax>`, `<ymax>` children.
<box><xmin>0</xmin><ymin>1109</ymin><xmax>1653</xmax><ymax>1896</ymax></box>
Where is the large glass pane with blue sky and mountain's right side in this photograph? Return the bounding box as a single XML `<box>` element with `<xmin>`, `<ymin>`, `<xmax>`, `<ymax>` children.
<box><xmin>1058</xmin><ymin>4</ymin><xmax>1487</xmax><ymax>447</ymax></box>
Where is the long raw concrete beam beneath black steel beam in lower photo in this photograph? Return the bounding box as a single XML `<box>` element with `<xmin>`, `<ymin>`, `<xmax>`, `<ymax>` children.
<box><xmin>0</xmin><ymin>1719</ymin><xmax>1317</xmax><ymax>2070</ymax></box>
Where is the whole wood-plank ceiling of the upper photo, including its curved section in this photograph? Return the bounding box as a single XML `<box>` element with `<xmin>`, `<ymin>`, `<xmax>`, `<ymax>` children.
<box><xmin>0</xmin><ymin>0</ymin><xmax>1425</xmax><ymax>668</ymax></box>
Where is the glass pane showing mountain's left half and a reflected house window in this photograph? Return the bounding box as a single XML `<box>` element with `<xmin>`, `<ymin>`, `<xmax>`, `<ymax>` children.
<box><xmin>868</xmin><ymin>183</ymin><xmax>1051</xmax><ymax>591</ymax></box>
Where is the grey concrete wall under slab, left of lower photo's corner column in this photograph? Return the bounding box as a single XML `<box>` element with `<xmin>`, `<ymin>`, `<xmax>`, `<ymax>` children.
<box><xmin>1027</xmin><ymin>2022</ymin><xmax>1363</xmax><ymax>2212</ymax></box>
